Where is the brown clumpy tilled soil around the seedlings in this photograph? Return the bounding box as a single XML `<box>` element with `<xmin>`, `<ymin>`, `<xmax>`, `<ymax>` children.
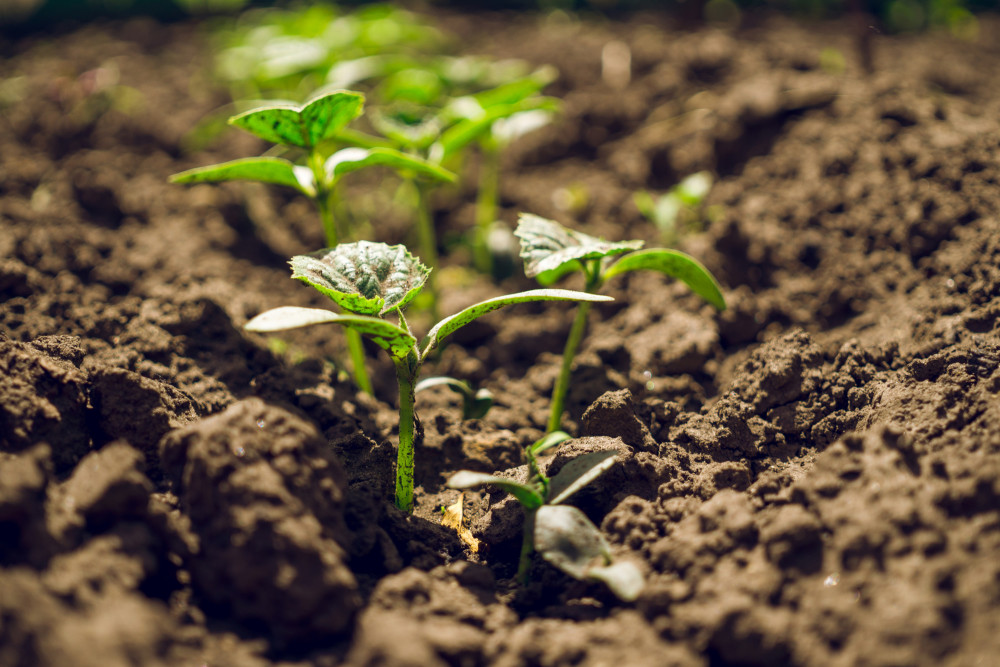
<box><xmin>0</xmin><ymin>9</ymin><xmax>1000</xmax><ymax>667</ymax></box>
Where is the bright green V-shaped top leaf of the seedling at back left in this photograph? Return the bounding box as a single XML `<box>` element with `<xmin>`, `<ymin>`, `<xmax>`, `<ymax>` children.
<box><xmin>229</xmin><ymin>90</ymin><xmax>365</xmax><ymax>149</ymax></box>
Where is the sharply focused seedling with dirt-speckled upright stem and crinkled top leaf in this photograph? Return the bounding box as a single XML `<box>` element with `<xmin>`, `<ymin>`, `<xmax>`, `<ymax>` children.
<box><xmin>245</xmin><ymin>241</ymin><xmax>610</xmax><ymax>512</ymax></box>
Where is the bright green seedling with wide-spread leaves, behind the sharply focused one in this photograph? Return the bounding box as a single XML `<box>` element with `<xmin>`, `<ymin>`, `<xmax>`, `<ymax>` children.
<box><xmin>170</xmin><ymin>90</ymin><xmax>455</xmax><ymax>394</ymax></box>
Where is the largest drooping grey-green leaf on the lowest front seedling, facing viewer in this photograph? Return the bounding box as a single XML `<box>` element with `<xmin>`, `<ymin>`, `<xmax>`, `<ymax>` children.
<box><xmin>535</xmin><ymin>505</ymin><xmax>611</xmax><ymax>579</ymax></box>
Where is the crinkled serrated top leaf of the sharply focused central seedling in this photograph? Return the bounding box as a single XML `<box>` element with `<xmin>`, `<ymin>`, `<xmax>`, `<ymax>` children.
<box><xmin>289</xmin><ymin>241</ymin><xmax>431</xmax><ymax>315</ymax></box>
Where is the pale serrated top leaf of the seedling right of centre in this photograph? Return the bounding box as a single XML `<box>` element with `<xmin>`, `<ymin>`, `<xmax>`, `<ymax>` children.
<box><xmin>514</xmin><ymin>213</ymin><xmax>643</xmax><ymax>278</ymax></box>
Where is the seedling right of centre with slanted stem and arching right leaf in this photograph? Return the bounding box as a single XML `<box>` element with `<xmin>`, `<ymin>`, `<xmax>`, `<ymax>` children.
<box><xmin>514</xmin><ymin>213</ymin><xmax>726</xmax><ymax>432</ymax></box>
